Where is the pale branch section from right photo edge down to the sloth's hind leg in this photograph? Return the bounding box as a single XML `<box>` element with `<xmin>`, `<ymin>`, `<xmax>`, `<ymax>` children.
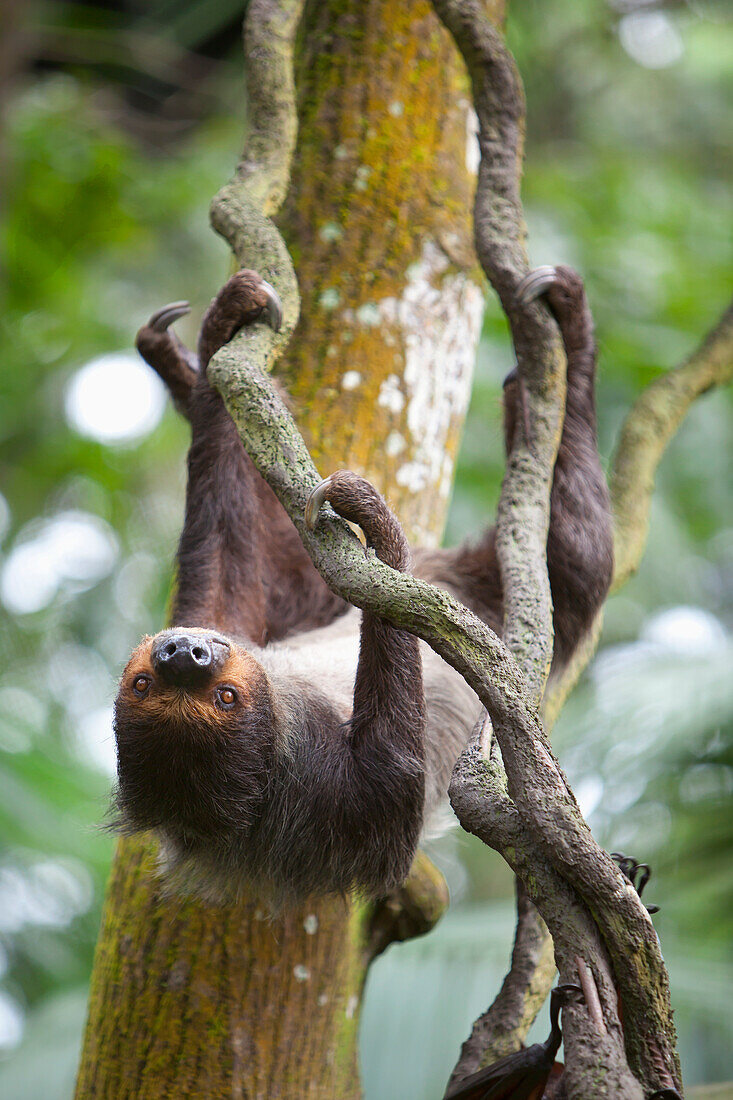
<box><xmin>611</xmin><ymin>303</ymin><xmax>733</xmax><ymax>589</ymax></box>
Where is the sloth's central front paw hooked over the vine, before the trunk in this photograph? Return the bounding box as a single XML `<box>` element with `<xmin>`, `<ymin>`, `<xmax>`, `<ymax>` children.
<box><xmin>305</xmin><ymin>470</ymin><xmax>409</xmax><ymax>572</ymax></box>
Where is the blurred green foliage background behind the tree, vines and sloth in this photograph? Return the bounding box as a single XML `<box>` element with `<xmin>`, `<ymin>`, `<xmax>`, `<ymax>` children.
<box><xmin>0</xmin><ymin>0</ymin><xmax>733</xmax><ymax>1100</ymax></box>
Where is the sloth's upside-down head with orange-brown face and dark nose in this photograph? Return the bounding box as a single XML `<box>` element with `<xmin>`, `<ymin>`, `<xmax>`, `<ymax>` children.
<box><xmin>114</xmin><ymin>627</ymin><xmax>275</xmax><ymax>843</ymax></box>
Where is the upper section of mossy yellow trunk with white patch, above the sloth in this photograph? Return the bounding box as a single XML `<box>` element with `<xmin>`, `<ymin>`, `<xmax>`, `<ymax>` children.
<box><xmin>278</xmin><ymin>0</ymin><xmax>483</xmax><ymax>546</ymax></box>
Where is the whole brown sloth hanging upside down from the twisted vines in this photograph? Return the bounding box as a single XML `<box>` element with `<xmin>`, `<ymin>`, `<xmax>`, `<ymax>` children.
<box><xmin>114</xmin><ymin>267</ymin><xmax>613</xmax><ymax>906</ymax></box>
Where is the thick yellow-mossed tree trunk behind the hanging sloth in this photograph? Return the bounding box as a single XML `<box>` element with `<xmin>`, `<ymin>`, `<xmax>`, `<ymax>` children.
<box><xmin>76</xmin><ymin>0</ymin><xmax>482</xmax><ymax>1100</ymax></box>
